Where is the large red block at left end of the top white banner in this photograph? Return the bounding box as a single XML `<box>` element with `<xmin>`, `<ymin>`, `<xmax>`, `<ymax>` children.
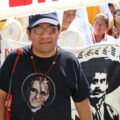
<box><xmin>9</xmin><ymin>0</ymin><xmax>32</xmax><ymax>7</ymax></box>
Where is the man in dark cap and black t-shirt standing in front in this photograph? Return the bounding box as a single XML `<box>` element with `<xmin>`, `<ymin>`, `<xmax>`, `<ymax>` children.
<box><xmin>0</xmin><ymin>13</ymin><xmax>92</xmax><ymax>120</ymax></box>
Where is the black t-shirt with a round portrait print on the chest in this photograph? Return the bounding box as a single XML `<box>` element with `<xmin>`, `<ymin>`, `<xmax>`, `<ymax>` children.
<box><xmin>0</xmin><ymin>46</ymin><xmax>90</xmax><ymax>120</ymax></box>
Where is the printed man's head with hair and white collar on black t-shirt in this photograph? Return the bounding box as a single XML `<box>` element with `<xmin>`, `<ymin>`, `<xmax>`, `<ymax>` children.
<box><xmin>27</xmin><ymin>77</ymin><xmax>49</xmax><ymax>112</ymax></box>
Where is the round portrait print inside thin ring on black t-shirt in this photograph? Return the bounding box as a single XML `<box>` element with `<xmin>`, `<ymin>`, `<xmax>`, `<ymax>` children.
<box><xmin>21</xmin><ymin>73</ymin><xmax>55</xmax><ymax>112</ymax></box>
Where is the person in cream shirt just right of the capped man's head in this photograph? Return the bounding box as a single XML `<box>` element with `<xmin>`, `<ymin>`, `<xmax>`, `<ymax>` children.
<box><xmin>58</xmin><ymin>10</ymin><xmax>85</xmax><ymax>48</ymax></box>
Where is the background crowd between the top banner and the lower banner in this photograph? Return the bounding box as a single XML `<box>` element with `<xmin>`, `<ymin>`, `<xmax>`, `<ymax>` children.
<box><xmin>0</xmin><ymin>3</ymin><xmax>120</xmax><ymax>63</ymax></box>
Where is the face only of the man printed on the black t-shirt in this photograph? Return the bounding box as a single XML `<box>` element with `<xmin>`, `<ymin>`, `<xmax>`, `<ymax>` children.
<box><xmin>29</xmin><ymin>81</ymin><xmax>49</xmax><ymax>108</ymax></box>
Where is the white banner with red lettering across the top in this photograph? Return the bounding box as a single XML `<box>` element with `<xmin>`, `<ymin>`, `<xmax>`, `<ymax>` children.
<box><xmin>0</xmin><ymin>0</ymin><xmax>120</xmax><ymax>19</ymax></box>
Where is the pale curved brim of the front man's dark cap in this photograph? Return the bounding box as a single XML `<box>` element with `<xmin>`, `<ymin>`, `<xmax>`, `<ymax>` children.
<box><xmin>31</xmin><ymin>18</ymin><xmax>59</xmax><ymax>27</ymax></box>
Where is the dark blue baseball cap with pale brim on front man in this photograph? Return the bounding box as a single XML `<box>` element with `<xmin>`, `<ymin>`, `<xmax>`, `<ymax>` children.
<box><xmin>28</xmin><ymin>12</ymin><xmax>59</xmax><ymax>28</ymax></box>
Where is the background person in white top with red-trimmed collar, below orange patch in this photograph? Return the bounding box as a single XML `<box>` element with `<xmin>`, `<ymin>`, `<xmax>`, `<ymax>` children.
<box><xmin>91</xmin><ymin>13</ymin><xmax>114</xmax><ymax>44</ymax></box>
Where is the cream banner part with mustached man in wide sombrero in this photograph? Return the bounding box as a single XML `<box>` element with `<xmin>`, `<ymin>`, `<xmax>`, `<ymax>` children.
<box><xmin>72</xmin><ymin>44</ymin><xmax>120</xmax><ymax>120</ymax></box>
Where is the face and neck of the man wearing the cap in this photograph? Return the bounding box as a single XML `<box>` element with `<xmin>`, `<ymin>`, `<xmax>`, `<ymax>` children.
<box><xmin>27</xmin><ymin>23</ymin><xmax>59</xmax><ymax>57</ymax></box>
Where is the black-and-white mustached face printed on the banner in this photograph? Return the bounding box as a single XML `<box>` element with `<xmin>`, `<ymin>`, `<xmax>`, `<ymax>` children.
<box><xmin>90</xmin><ymin>73</ymin><xmax>108</xmax><ymax>98</ymax></box>
